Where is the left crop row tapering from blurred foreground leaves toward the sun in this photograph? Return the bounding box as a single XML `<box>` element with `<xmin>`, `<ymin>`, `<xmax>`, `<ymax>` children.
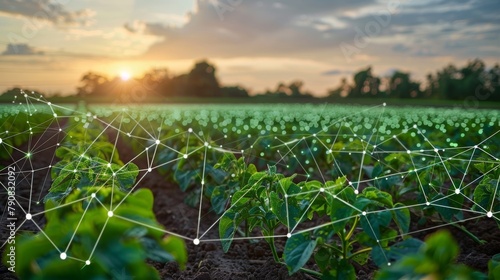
<box><xmin>5</xmin><ymin>112</ymin><xmax>187</xmax><ymax>279</ymax></box>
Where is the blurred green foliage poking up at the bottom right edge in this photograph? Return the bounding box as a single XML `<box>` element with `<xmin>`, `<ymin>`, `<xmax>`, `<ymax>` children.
<box><xmin>376</xmin><ymin>231</ymin><xmax>488</xmax><ymax>280</ymax></box>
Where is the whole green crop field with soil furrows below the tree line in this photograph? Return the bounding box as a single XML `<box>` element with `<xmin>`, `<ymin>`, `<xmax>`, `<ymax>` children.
<box><xmin>0</xmin><ymin>94</ymin><xmax>500</xmax><ymax>279</ymax></box>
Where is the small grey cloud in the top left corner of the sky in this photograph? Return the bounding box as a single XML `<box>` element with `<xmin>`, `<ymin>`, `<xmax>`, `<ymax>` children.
<box><xmin>0</xmin><ymin>0</ymin><xmax>94</xmax><ymax>26</ymax></box>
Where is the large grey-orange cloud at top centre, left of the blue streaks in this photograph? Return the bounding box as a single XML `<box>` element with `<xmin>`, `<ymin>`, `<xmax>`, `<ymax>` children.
<box><xmin>124</xmin><ymin>0</ymin><xmax>375</xmax><ymax>59</ymax></box>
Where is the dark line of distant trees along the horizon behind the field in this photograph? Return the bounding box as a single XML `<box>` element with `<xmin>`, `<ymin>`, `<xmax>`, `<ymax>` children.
<box><xmin>0</xmin><ymin>59</ymin><xmax>500</xmax><ymax>102</ymax></box>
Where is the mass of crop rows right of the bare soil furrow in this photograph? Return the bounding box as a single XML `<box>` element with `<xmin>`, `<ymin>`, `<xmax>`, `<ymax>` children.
<box><xmin>95</xmin><ymin>104</ymin><xmax>500</xmax><ymax>279</ymax></box>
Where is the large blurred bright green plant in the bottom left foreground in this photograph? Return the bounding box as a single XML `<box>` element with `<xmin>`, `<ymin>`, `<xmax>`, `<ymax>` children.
<box><xmin>6</xmin><ymin>187</ymin><xmax>187</xmax><ymax>279</ymax></box>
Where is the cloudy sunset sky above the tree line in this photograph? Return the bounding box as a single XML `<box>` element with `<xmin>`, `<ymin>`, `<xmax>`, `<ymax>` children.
<box><xmin>0</xmin><ymin>0</ymin><xmax>500</xmax><ymax>95</ymax></box>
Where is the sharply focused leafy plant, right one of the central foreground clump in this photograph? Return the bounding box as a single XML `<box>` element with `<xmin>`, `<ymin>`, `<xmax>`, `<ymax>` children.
<box><xmin>284</xmin><ymin>182</ymin><xmax>411</xmax><ymax>279</ymax></box>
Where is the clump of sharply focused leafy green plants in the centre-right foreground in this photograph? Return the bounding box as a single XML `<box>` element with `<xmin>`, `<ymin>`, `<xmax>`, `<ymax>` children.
<box><xmin>219</xmin><ymin>166</ymin><xmax>410</xmax><ymax>279</ymax></box>
